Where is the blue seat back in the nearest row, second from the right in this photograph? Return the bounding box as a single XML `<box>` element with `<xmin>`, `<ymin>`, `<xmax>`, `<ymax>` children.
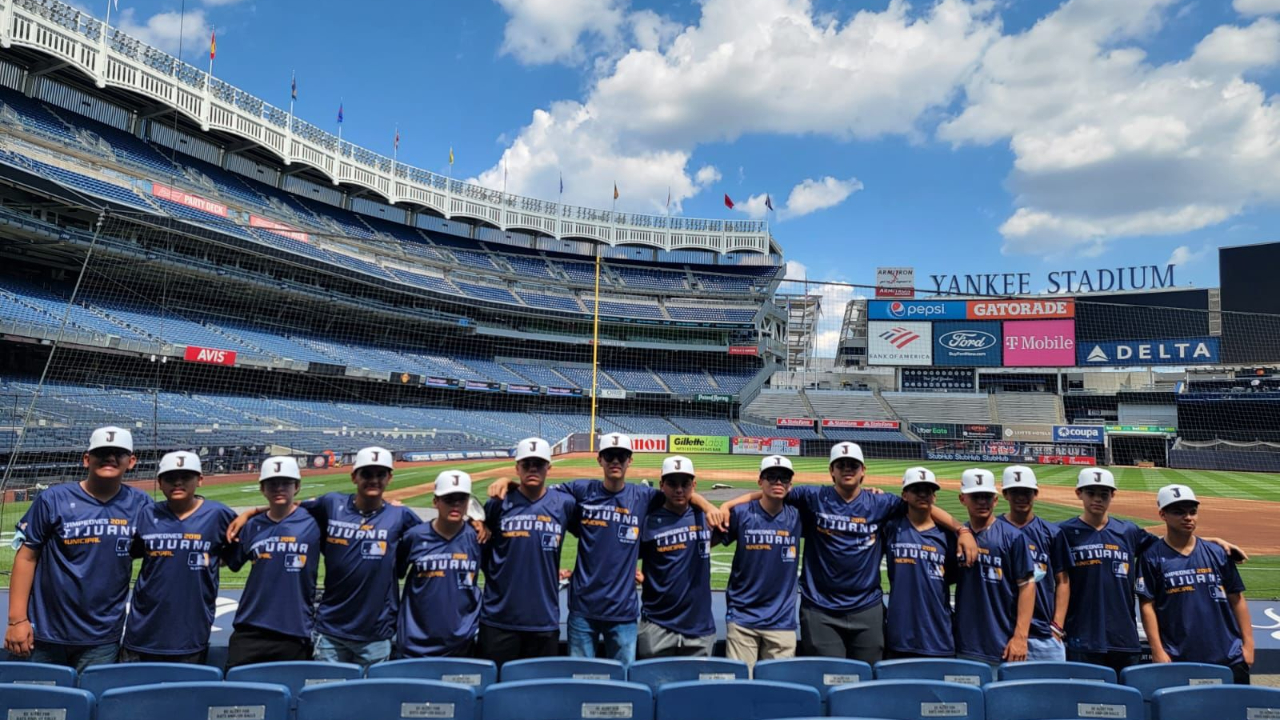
<box><xmin>984</xmin><ymin>680</ymin><xmax>1142</xmax><ymax>720</ymax></box>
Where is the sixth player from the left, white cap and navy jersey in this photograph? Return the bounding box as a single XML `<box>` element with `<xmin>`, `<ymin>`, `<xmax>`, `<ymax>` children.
<box><xmin>479</xmin><ymin>438</ymin><xmax>577</xmax><ymax>665</ymax></box>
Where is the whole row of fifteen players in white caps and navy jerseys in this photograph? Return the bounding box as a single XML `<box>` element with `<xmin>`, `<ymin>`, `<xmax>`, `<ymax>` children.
<box><xmin>5</xmin><ymin>427</ymin><xmax>1253</xmax><ymax>683</ymax></box>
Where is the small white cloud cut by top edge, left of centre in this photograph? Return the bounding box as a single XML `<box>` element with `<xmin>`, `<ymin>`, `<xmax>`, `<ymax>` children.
<box><xmin>498</xmin><ymin>0</ymin><xmax>624</xmax><ymax>65</ymax></box>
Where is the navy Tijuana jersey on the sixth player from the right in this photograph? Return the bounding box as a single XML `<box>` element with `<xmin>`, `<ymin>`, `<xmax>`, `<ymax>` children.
<box><xmin>787</xmin><ymin>486</ymin><xmax>906</xmax><ymax>612</ymax></box>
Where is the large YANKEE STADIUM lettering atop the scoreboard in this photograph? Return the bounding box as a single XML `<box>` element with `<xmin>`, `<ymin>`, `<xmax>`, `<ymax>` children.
<box><xmin>929</xmin><ymin>264</ymin><xmax>1174</xmax><ymax>296</ymax></box>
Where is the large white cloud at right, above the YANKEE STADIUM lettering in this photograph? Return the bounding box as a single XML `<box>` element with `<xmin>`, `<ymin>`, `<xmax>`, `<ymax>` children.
<box><xmin>938</xmin><ymin>0</ymin><xmax>1280</xmax><ymax>255</ymax></box>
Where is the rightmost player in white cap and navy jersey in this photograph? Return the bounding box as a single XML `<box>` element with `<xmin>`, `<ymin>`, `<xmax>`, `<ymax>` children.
<box><xmin>1138</xmin><ymin>486</ymin><xmax>1253</xmax><ymax>685</ymax></box>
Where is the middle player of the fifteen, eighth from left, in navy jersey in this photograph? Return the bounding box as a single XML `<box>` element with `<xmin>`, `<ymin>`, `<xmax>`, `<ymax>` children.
<box><xmin>636</xmin><ymin>455</ymin><xmax>716</xmax><ymax>660</ymax></box>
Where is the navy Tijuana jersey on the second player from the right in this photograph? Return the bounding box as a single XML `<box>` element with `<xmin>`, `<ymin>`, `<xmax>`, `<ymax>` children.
<box><xmin>1057</xmin><ymin>518</ymin><xmax>1160</xmax><ymax>652</ymax></box>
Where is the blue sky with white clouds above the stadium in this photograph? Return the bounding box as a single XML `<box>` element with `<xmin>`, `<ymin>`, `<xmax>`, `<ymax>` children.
<box><xmin>97</xmin><ymin>0</ymin><xmax>1280</xmax><ymax>290</ymax></box>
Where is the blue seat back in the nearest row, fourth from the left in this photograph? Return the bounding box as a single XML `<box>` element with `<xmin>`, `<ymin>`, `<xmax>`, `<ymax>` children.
<box><xmin>481</xmin><ymin>680</ymin><xmax>653</xmax><ymax>720</ymax></box>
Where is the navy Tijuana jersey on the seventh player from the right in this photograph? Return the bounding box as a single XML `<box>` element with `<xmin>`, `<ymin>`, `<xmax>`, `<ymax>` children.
<box><xmin>721</xmin><ymin>500</ymin><xmax>801</xmax><ymax>630</ymax></box>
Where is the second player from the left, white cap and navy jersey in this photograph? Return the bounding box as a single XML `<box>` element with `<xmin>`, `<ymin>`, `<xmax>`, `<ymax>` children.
<box><xmin>120</xmin><ymin>451</ymin><xmax>236</xmax><ymax>664</ymax></box>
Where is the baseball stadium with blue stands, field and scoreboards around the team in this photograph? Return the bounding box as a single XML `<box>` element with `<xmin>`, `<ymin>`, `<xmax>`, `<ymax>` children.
<box><xmin>0</xmin><ymin>0</ymin><xmax>1280</xmax><ymax>720</ymax></box>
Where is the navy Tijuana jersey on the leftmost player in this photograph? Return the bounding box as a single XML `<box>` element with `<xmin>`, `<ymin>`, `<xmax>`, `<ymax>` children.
<box><xmin>23</xmin><ymin>483</ymin><xmax>152</xmax><ymax>644</ymax></box>
